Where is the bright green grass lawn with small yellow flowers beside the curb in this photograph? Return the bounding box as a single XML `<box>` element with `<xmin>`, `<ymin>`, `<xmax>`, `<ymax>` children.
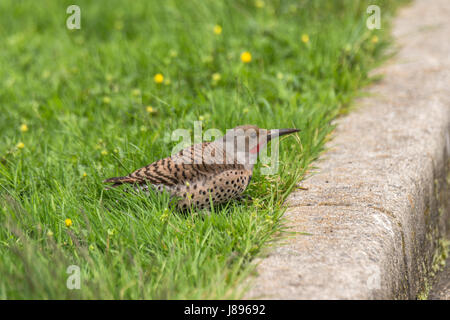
<box><xmin>0</xmin><ymin>0</ymin><xmax>404</xmax><ymax>299</ymax></box>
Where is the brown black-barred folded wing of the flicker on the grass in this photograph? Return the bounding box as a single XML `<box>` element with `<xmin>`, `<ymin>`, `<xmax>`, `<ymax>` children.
<box><xmin>106</xmin><ymin>142</ymin><xmax>242</xmax><ymax>186</ymax></box>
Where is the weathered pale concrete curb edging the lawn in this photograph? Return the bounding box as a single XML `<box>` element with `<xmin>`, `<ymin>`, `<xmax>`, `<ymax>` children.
<box><xmin>246</xmin><ymin>0</ymin><xmax>450</xmax><ymax>299</ymax></box>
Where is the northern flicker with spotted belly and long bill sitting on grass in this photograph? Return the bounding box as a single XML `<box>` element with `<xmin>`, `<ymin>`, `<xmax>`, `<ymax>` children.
<box><xmin>104</xmin><ymin>125</ymin><xmax>299</xmax><ymax>210</ymax></box>
